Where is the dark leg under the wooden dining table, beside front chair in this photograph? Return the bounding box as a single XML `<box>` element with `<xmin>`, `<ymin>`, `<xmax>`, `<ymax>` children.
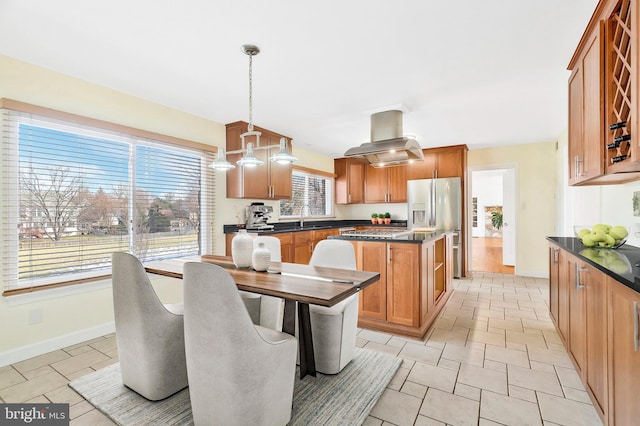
<box><xmin>282</xmin><ymin>299</ymin><xmax>316</xmax><ymax>379</ymax></box>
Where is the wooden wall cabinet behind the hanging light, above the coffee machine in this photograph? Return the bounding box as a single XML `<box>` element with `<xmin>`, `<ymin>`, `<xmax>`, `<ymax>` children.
<box><xmin>226</xmin><ymin>121</ymin><xmax>292</xmax><ymax>200</ymax></box>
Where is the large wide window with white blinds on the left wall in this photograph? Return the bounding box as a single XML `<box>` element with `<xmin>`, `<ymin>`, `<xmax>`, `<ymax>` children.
<box><xmin>0</xmin><ymin>105</ymin><xmax>214</xmax><ymax>294</ymax></box>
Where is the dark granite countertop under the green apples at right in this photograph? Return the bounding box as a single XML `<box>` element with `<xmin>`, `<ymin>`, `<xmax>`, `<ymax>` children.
<box><xmin>547</xmin><ymin>237</ymin><xmax>640</xmax><ymax>293</ymax></box>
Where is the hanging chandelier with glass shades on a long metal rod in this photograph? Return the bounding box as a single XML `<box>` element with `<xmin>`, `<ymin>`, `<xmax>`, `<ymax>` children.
<box><xmin>210</xmin><ymin>44</ymin><xmax>298</xmax><ymax>171</ymax></box>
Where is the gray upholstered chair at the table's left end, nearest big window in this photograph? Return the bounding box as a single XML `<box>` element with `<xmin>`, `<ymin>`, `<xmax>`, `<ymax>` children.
<box><xmin>111</xmin><ymin>253</ymin><xmax>187</xmax><ymax>401</ymax></box>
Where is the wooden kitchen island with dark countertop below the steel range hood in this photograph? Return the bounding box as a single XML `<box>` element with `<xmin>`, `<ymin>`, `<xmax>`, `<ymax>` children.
<box><xmin>328</xmin><ymin>231</ymin><xmax>453</xmax><ymax>338</ymax></box>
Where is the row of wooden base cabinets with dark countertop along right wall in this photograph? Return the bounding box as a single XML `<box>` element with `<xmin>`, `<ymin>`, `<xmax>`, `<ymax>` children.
<box><xmin>547</xmin><ymin>237</ymin><xmax>640</xmax><ymax>425</ymax></box>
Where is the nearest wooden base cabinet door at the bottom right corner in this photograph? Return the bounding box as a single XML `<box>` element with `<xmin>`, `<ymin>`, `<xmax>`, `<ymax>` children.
<box><xmin>608</xmin><ymin>280</ymin><xmax>640</xmax><ymax>425</ymax></box>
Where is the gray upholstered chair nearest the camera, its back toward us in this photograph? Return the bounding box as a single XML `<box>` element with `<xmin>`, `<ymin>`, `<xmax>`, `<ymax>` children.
<box><xmin>183</xmin><ymin>262</ymin><xmax>297</xmax><ymax>425</ymax></box>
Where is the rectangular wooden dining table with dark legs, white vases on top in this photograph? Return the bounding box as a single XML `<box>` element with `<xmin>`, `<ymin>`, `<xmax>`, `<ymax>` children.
<box><xmin>144</xmin><ymin>254</ymin><xmax>380</xmax><ymax>378</ymax></box>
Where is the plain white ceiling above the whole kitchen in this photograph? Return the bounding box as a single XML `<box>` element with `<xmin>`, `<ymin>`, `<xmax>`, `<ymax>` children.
<box><xmin>0</xmin><ymin>0</ymin><xmax>597</xmax><ymax>157</ymax></box>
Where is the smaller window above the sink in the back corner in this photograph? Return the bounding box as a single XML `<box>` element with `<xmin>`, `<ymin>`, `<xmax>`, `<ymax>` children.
<box><xmin>280</xmin><ymin>169</ymin><xmax>333</xmax><ymax>219</ymax></box>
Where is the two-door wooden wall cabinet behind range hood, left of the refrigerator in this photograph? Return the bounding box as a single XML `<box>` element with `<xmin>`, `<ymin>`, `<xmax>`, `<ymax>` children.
<box><xmin>364</xmin><ymin>166</ymin><xmax>407</xmax><ymax>203</ymax></box>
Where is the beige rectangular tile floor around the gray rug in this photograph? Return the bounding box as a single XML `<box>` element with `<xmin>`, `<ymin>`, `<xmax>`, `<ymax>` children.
<box><xmin>0</xmin><ymin>273</ymin><xmax>601</xmax><ymax>426</ymax></box>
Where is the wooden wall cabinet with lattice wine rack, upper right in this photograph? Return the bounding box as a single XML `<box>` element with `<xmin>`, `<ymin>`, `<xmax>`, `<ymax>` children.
<box><xmin>568</xmin><ymin>0</ymin><xmax>640</xmax><ymax>185</ymax></box>
